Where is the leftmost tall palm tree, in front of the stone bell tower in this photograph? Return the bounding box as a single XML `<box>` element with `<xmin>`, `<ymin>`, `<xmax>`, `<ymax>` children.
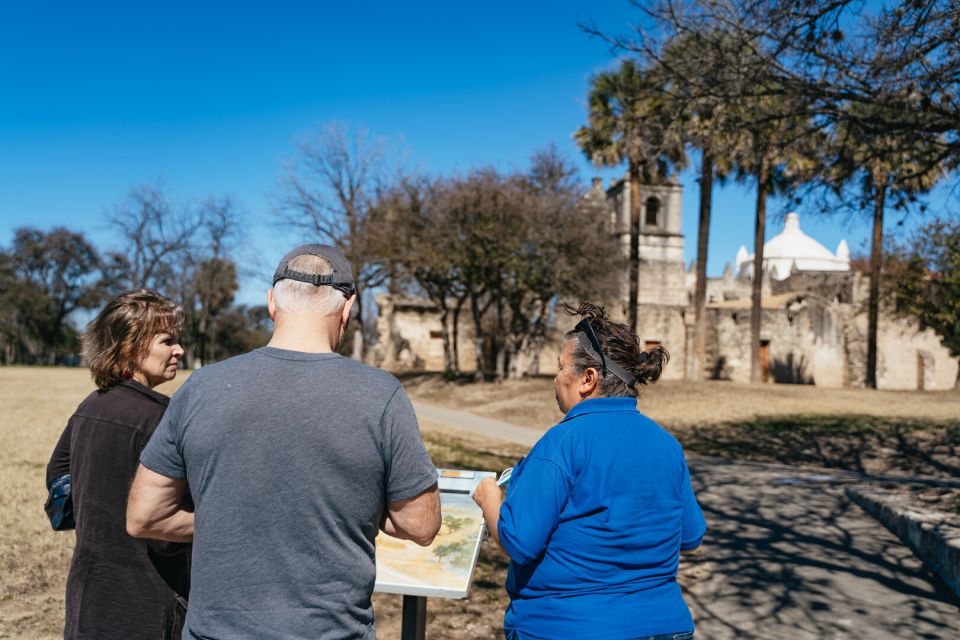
<box><xmin>574</xmin><ymin>60</ymin><xmax>686</xmax><ymax>330</ymax></box>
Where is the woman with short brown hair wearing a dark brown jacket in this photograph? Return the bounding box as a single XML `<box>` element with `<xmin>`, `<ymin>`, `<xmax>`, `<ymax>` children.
<box><xmin>47</xmin><ymin>289</ymin><xmax>189</xmax><ymax>640</ymax></box>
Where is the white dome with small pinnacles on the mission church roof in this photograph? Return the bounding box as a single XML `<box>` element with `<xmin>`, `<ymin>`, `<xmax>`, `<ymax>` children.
<box><xmin>737</xmin><ymin>213</ymin><xmax>850</xmax><ymax>280</ymax></box>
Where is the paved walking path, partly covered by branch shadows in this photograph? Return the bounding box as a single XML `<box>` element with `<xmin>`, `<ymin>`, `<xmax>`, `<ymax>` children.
<box><xmin>414</xmin><ymin>402</ymin><xmax>960</xmax><ymax>640</ymax></box>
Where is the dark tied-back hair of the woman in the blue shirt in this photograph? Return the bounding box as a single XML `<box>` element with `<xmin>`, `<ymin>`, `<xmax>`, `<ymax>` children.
<box><xmin>563</xmin><ymin>302</ymin><xmax>670</xmax><ymax>398</ymax></box>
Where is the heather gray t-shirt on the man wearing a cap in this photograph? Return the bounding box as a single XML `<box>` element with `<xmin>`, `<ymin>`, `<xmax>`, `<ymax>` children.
<box><xmin>140</xmin><ymin>347</ymin><xmax>437</xmax><ymax>640</ymax></box>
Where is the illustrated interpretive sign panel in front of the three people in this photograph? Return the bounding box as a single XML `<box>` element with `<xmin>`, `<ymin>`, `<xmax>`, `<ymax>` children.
<box><xmin>375</xmin><ymin>469</ymin><xmax>495</xmax><ymax>598</ymax></box>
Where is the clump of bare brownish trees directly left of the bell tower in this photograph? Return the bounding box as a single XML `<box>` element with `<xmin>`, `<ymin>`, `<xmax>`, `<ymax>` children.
<box><xmin>377</xmin><ymin>148</ymin><xmax>626</xmax><ymax>379</ymax></box>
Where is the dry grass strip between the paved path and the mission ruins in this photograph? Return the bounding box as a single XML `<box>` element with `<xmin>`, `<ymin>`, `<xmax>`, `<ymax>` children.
<box><xmin>404</xmin><ymin>375</ymin><xmax>960</xmax><ymax>478</ymax></box>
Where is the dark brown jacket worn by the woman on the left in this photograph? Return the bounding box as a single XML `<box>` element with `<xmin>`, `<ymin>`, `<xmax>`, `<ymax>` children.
<box><xmin>47</xmin><ymin>380</ymin><xmax>189</xmax><ymax>640</ymax></box>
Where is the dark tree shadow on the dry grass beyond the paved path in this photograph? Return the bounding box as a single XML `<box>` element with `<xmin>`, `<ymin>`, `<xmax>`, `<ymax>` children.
<box><xmin>673</xmin><ymin>415</ymin><xmax>960</xmax><ymax>477</ymax></box>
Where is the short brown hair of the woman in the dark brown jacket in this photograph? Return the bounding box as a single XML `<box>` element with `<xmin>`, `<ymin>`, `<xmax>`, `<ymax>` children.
<box><xmin>83</xmin><ymin>289</ymin><xmax>184</xmax><ymax>389</ymax></box>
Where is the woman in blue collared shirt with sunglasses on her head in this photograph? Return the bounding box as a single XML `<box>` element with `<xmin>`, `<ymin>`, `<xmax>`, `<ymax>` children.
<box><xmin>474</xmin><ymin>304</ymin><xmax>706</xmax><ymax>640</ymax></box>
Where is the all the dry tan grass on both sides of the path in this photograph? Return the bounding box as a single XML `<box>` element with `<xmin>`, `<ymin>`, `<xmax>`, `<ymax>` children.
<box><xmin>0</xmin><ymin>367</ymin><xmax>960</xmax><ymax>640</ymax></box>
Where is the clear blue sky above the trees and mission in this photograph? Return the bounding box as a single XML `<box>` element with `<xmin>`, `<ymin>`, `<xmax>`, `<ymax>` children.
<box><xmin>0</xmin><ymin>0</ymin><xmax>944</xmax><ymax>303</ymax></box>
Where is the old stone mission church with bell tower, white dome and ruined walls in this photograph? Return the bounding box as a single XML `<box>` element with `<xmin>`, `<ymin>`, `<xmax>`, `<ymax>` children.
<box><xmin>375</xmin><ymin>179</ymin><xmax>958</xmax><ymax>390</ymax></box>
